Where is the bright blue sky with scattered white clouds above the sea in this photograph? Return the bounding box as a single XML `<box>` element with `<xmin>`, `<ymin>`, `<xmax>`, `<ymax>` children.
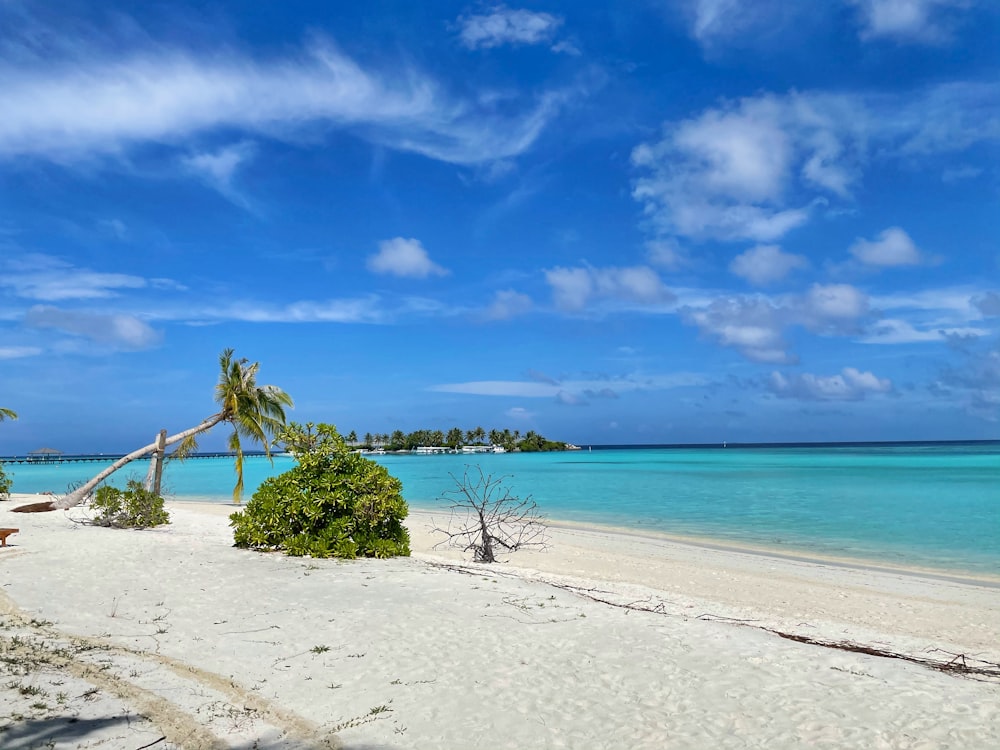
<box><xmin>0</xmin><ymin>0</ymin><xmax>1000</xmax><ymax>454</ymax></box>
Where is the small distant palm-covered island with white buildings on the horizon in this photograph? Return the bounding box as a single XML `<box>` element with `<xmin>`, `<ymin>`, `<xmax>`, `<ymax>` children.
<box><xmin>344</xmin><ymin>427</ymin><xmax>579</xmax><ymax>454</ymax></box>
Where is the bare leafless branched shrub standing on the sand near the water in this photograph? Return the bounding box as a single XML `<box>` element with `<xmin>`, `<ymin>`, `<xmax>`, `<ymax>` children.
<box><xmin>434</xmin><ymin>466</ymin><xmax>548</xmax><ymax>563</ymax></box>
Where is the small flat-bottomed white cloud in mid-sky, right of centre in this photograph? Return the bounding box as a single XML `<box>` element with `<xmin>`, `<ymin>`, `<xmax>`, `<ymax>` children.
<box><xmin>545</xmin><ymin>266</ymin><xmax>675</xmax><ymax>312</ymax></box>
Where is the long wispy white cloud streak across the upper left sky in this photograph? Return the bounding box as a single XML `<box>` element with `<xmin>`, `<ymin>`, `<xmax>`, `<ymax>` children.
<box><xmin>0</xmin><ymin>40</ymin><xmax>567</xmax><ymax>166</ymax></box>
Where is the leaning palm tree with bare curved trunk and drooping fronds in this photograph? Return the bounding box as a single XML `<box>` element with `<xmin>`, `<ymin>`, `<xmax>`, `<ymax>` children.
<box><xmin>14</xmin><ymin>349</ymin><xmax>292</xmax><ymax>512</ymax></box>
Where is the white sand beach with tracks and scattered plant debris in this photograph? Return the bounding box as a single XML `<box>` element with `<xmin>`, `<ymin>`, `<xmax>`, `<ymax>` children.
<box><xmin>0</xmin><ymin>496</ymin><xmax>1000</xmax><ymax>750</ymax></box>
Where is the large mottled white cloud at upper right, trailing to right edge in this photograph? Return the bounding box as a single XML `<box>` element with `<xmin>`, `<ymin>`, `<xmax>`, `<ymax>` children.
<box><xmin>632</xmin><ymin>83</ymin><xmax>1000</xmax><ymax>243</ymax></box>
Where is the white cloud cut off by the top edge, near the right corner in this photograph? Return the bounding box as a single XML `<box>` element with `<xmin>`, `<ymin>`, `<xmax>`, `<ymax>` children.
<box><xmin>850</xmin><ymin>0</ymin><xmax>969</xmax><ymax>42</ymax></box>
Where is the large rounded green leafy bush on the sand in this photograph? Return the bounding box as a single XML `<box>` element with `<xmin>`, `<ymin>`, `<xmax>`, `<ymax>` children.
<box><xmin>229</xmin><ymin>423</ymin><xmax>410</xmax><ymax>558</ymax></box>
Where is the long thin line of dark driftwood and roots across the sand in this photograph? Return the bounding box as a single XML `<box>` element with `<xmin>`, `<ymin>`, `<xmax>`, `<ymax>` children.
<box><xmin>429</xmin><ymin>563</ymin><xmax>1000</xmax><ymax>681</ymax></box>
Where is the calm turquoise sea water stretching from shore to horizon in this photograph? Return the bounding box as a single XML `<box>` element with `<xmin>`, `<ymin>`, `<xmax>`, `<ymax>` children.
<box><xmin>6</xmin><ymin>443</ymin><xmax>1000</xmax><ymax>575</ymax></box>
